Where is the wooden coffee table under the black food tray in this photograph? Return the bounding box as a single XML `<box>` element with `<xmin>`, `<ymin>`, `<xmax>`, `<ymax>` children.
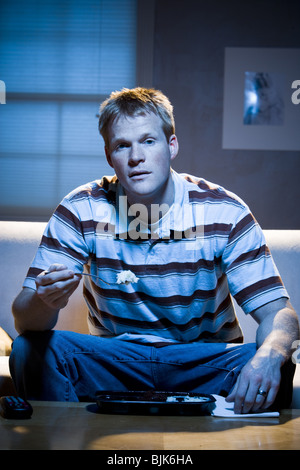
<box><xmin>0</xmin><ymin>402</ymin><xmax>300</xmax><ymax>455</ymax></box>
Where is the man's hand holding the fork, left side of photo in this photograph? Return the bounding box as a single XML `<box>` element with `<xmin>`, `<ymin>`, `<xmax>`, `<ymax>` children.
<box><xmin>35</xmin><ymin>264</ymin><xmax>81</xmax><ymax>310</ymax></box>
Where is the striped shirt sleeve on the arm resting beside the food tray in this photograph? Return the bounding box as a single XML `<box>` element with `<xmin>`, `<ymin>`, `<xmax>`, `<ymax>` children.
<box><xmin>222</xmin><ymin>206</ymin><xmax>289</xmax><ymax>313</ymax></box>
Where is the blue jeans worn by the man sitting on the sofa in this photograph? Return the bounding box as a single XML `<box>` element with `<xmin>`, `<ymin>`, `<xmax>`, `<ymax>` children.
<box><xmin>10</xmin><ymin>331</ymin><xmax>256</xmax><ymax>401</ymax></box>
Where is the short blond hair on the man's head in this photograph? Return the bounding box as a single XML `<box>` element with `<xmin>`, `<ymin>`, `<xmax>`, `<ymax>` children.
<box><xmin>99</xmin><ymin>87</ymin><xmax>175</xmax><ymax>145</ymax></box>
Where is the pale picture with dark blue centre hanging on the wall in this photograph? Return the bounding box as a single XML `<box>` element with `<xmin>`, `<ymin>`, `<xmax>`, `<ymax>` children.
<box><xmin>223</xmin><ymin>47</ymin><xmax>300</xmax><ymax>151</ymax></box>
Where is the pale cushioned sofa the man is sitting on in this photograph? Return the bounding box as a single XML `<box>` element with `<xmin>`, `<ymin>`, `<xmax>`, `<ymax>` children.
<box><xmin>0</xmin><ymin>221</ymin><xmax>300</xmax><ymax>408</ymax></box>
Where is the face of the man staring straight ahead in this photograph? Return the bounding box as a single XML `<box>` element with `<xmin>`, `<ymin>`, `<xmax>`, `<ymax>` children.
<box><xmin>105</xmin><ymin>113</ymin><xmax>178</xmax><ymax>206</ymax></box>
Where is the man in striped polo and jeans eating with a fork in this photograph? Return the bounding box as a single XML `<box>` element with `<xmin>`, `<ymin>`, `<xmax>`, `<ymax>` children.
<box><xmin>10</xmin><ymin>88</ymin><xmax>299</xmax><ymax>413</ymax></box>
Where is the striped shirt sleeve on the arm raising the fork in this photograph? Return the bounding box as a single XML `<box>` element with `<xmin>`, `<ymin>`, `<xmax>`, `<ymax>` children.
<box><xmin>23</xmin><ymin>199</ymin><xmax>90</xmax><ymax>289</ymax></box>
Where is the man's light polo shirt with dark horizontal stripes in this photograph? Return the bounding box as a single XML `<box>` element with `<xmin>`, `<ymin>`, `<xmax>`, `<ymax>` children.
<box><xmin>24</xmin><ymin>170</ymin><xmax>288</xmax><ymax>345</ymax></box>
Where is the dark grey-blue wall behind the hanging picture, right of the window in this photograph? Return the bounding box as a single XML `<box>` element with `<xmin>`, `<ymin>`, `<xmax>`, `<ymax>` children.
<box><xmin>153</xmin><ymin>0</ymin><xmax>300</xmax><ymax>229</ymax></box>
